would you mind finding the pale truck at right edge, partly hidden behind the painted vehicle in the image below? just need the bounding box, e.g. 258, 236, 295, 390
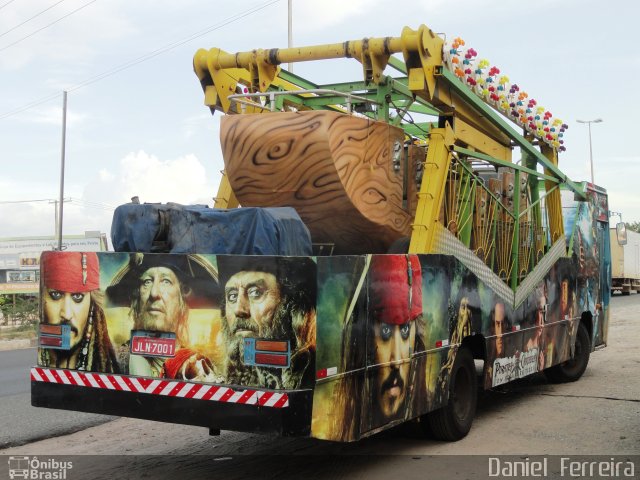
609, 228, 640, 295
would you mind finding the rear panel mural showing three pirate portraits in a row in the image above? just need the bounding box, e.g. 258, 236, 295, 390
39, 252, 316, 389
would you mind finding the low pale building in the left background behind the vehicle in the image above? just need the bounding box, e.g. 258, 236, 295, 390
0, 231, 108, 295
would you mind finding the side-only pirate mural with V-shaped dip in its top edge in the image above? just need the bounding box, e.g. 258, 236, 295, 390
312, 251, 596, 441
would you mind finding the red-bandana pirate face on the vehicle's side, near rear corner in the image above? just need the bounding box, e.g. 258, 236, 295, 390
369, 255, 423, 427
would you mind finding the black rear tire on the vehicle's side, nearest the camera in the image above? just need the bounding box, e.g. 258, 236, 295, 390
427, 347, 478, 441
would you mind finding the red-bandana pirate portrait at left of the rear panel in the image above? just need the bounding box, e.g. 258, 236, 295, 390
38, 252, 119, 373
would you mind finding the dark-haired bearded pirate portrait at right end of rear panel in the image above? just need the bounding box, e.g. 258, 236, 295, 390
217, 255, 317, 389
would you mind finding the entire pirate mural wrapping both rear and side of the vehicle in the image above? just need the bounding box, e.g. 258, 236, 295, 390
39, 224, 606, 441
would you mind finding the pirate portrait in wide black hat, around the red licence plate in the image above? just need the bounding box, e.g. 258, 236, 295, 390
107, 253, 222, 382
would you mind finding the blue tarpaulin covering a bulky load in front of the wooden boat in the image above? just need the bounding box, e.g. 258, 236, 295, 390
111, 203, 312, 256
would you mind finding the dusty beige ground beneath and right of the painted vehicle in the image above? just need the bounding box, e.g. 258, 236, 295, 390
0, 295, 640, 480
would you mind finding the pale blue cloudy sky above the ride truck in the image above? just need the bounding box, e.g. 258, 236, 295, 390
0, 0, 640, 248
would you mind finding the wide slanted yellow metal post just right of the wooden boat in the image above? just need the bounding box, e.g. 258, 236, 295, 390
409, 124, 455, 253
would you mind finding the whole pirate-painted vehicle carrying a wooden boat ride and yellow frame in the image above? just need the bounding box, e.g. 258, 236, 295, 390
31, 25, 611, 442
